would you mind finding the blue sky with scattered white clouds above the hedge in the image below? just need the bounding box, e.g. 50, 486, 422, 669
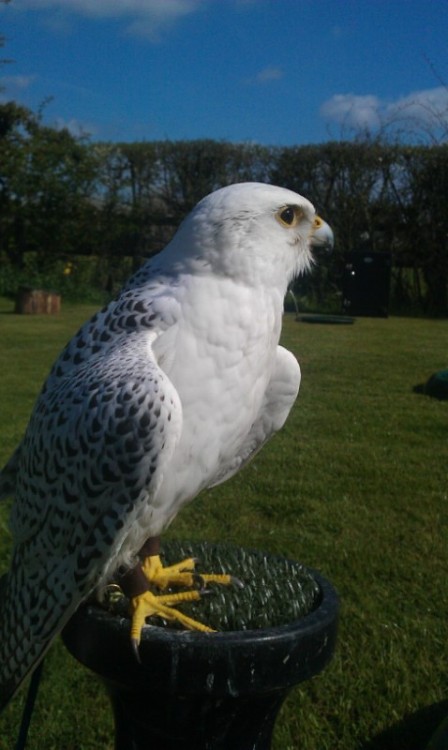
0, 0, 448, 145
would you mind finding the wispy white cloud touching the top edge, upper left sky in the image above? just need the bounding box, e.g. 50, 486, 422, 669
14, 0, 200, 39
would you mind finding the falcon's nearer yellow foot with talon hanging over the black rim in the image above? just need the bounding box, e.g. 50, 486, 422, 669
131, 591, 214, 657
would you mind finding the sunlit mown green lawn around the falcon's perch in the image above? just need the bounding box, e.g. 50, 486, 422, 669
0, 301, 448, 750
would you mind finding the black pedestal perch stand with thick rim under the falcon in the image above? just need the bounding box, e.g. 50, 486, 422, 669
63, 545, 338, 750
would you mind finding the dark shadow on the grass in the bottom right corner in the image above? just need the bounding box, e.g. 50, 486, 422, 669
360, 700, 448, 750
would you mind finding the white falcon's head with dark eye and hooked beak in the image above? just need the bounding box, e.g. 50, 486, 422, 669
170, 182, 333, 289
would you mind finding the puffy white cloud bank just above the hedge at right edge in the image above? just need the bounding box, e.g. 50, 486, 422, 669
320, 86, 448, 137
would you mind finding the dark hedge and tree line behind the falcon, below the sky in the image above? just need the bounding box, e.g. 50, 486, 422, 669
0, 102, 448, 316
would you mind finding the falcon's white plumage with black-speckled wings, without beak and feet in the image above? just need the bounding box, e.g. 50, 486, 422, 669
0, 183, 332, 706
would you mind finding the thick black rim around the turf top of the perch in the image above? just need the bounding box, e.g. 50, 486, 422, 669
63, 566, 339, 696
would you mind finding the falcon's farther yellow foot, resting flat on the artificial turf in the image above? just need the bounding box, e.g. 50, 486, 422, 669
142, 555, 233, 591
